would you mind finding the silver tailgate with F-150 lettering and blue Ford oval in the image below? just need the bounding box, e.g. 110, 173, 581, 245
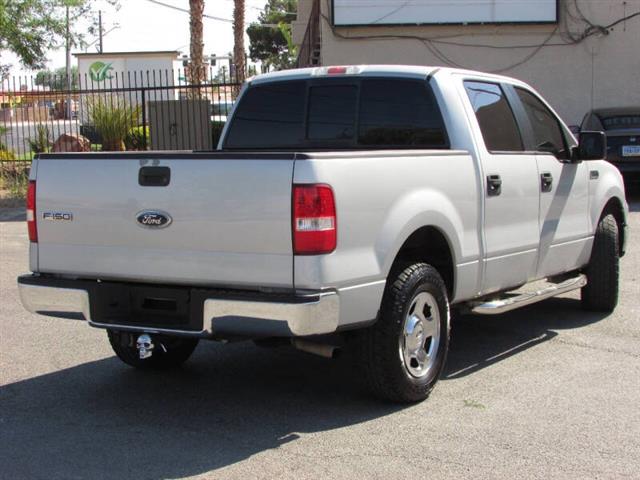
36, 152, 295, 288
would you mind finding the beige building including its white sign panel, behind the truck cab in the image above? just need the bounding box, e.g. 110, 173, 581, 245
293, 0, 640, 125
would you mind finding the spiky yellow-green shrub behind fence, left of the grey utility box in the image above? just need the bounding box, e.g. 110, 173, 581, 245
89, 99, 141, 151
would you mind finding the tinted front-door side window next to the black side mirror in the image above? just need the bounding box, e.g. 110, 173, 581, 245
516, 88, 567, 158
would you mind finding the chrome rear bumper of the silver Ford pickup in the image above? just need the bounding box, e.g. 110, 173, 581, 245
18, 275, 340, 338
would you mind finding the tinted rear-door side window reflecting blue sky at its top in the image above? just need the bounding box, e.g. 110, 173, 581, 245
464, 81, 524, 152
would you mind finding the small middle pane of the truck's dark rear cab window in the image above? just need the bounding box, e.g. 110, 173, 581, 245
308, 85, 357, 140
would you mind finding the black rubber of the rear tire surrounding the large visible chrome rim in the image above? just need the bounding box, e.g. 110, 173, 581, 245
354, 263, 450, 403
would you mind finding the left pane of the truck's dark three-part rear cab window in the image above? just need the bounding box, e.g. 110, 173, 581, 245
225, 81, 306, 149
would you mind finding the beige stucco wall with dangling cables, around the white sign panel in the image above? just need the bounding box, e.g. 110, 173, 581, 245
300, 0, 640, 124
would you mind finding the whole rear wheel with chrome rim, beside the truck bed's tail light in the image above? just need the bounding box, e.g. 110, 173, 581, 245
355, 263, 450, 402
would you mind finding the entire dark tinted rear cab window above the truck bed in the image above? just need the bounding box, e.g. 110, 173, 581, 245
223, 77, 449, 150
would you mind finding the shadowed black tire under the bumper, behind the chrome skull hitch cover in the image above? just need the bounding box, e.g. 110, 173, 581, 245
107, 330, 198, 370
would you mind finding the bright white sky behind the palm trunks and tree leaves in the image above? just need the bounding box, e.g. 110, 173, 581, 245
2, 0, 266, 75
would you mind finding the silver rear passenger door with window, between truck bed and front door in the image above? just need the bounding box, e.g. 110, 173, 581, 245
464, 80, 540, 292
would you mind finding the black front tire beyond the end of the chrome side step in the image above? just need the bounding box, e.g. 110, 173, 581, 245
581, 214, 620, 312
